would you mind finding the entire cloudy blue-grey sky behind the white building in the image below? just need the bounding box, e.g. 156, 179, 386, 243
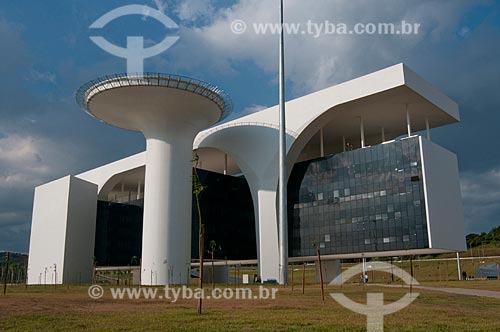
0, 0, 500, 252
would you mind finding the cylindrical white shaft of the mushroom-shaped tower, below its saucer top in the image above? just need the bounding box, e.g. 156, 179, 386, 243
141, 130, 194, 285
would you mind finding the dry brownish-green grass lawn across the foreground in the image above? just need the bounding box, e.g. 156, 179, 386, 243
0, 284, 500, 332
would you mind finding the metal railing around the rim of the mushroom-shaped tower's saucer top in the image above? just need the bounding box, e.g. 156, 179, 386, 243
76, 73, 233, 120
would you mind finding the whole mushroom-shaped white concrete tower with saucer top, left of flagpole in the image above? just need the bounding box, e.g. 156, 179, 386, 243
77, 74, 232, 285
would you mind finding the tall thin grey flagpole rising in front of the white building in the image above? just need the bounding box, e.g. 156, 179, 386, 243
278, 0, 288, 285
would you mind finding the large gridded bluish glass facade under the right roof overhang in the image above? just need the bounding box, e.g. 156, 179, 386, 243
288, 137, 429, 257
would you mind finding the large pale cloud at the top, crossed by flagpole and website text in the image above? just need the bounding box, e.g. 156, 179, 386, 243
169, 0, 482, 93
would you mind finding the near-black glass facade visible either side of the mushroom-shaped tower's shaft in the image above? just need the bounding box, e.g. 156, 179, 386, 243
94, 170, 257, 266
